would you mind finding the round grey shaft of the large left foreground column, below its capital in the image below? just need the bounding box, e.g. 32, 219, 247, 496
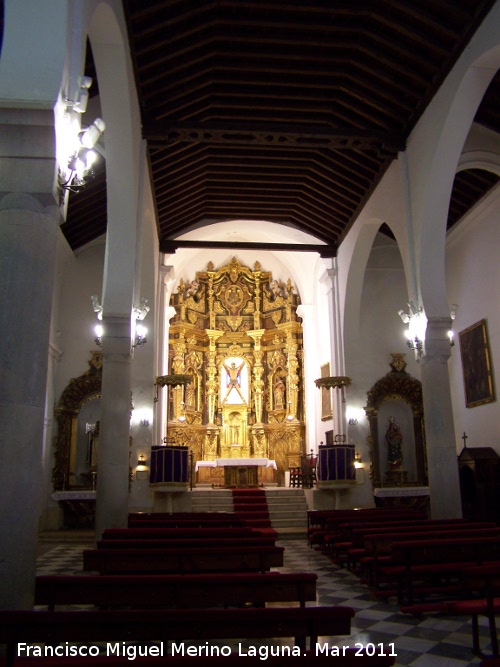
0, 194, 59, 609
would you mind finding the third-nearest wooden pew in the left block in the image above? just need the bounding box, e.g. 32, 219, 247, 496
83, 546, 284, 574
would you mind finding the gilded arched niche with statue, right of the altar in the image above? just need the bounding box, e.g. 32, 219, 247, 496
365, 354, 427, 488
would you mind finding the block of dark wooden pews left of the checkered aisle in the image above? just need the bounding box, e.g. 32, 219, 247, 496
0, 512, 395, 667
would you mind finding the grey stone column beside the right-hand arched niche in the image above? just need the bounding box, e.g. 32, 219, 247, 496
421, 317, 462, 519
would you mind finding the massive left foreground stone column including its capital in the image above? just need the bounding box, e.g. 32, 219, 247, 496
0, 103, 61, 609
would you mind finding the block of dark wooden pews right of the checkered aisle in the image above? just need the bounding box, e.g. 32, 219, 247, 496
308, 509, 500, 658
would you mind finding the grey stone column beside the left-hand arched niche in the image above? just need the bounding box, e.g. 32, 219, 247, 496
95, 315, 132, 539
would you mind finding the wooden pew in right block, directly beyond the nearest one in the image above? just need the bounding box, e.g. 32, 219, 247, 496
380, 537, 500, 605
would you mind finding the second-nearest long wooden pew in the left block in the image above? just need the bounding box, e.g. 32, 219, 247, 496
35, 572, 317, 611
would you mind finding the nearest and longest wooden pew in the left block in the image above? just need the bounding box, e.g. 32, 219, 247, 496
0, 606, 354, 667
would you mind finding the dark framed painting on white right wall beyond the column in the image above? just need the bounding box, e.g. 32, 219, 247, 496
458, 320, 495, 408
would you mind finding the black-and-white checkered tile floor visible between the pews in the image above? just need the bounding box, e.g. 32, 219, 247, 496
38, 538, 496, 667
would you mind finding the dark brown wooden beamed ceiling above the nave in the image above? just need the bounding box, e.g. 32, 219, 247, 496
65, 0, 500, 254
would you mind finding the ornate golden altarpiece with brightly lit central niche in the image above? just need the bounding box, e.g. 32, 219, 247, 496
164, 258, 304, 486
